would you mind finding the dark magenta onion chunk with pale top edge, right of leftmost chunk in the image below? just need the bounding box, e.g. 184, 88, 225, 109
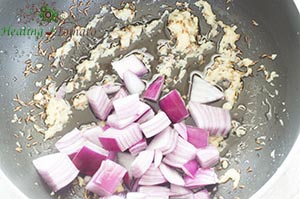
72, 141, 109, 176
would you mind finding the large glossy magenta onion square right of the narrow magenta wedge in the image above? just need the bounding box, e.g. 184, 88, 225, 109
159, 89, 189, 123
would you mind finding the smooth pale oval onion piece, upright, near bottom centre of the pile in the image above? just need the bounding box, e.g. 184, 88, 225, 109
130, 150, 154, 178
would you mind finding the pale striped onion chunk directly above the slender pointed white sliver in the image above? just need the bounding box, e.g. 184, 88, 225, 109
163, 137, 196, 168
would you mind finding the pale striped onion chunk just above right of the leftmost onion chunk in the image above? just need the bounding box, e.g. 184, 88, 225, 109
55, 128, 86, 159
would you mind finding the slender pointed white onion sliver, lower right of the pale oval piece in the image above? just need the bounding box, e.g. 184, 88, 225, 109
159, 163, 184, 186
